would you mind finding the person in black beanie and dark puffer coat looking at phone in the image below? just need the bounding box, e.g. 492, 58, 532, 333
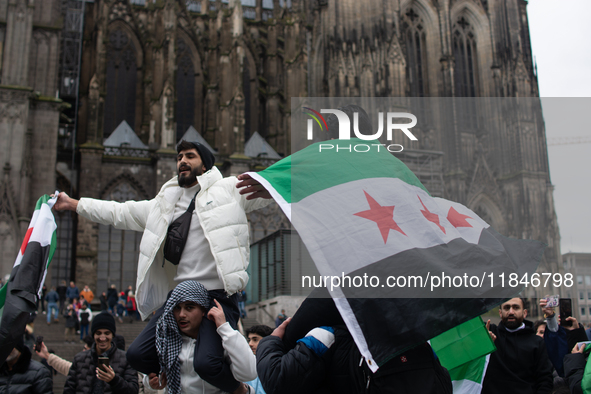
64, 312, 139, 394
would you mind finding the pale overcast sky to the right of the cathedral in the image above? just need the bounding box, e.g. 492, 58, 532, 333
527, 0, 591, 254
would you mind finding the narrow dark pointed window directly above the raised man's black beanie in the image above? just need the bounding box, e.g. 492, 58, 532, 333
175, 38, 198, 142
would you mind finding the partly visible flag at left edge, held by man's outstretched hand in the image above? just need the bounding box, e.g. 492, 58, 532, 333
0, 192, 58, 365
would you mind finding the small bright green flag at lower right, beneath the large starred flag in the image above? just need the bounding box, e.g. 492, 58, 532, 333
429, 317, 496, 394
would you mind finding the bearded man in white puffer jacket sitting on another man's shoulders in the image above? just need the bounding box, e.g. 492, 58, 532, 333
54, 141, 271, 393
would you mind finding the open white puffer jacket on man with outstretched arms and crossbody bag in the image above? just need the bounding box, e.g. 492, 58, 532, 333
76, 167, 271, 319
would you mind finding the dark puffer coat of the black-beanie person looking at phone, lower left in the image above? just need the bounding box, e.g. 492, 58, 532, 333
64, 343, 139, 394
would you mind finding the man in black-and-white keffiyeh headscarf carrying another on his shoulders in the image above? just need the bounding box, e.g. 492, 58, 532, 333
147, 281, 256, 394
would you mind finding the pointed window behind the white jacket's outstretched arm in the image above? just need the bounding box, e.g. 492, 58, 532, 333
96, 182, 142, 294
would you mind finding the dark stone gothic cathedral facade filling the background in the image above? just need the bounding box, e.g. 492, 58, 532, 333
0, 0, 562, 304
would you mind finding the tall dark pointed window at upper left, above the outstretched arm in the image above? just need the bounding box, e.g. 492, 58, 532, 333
103, 29, 137, 138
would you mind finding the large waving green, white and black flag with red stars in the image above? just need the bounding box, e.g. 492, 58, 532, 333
249, 139, 544, 371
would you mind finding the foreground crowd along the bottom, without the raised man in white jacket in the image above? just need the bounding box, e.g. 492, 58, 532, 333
9, 290, 591, 394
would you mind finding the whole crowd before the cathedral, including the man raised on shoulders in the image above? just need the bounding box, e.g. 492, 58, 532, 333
0, 136, 591, 394
